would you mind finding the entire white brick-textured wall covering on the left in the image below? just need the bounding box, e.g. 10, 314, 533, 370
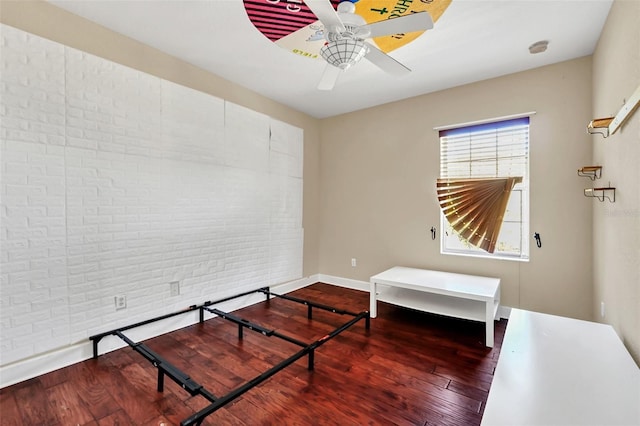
0, 25, 303, 366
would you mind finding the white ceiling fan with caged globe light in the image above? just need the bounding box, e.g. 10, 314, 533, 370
304, 0, 433, 90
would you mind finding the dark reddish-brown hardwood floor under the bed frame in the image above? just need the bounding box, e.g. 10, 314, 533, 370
0, 284, 506, 426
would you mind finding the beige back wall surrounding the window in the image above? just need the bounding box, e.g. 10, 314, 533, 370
319, 57, 592, 319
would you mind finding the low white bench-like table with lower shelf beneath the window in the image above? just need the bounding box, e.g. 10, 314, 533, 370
369, 266, 500, 347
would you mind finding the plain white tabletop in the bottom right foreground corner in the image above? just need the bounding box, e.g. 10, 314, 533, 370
482, 309, 640, 426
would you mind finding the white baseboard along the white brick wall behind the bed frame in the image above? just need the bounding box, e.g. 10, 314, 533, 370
0, 275, 319, 389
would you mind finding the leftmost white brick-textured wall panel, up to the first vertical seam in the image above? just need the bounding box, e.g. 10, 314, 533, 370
0, 27, 69, 364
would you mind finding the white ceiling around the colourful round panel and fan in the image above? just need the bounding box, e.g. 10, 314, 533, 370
49, 0, 612, 118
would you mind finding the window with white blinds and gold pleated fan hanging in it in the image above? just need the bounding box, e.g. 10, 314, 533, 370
438, 116, 529, 260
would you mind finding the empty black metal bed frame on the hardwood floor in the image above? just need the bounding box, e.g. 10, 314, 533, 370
89, 287, 370, 426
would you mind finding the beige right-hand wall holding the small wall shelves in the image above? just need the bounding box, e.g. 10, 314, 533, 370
592, 0, 640, 364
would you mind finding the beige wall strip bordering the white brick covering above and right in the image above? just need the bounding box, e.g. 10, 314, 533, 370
0, 0, 320, 275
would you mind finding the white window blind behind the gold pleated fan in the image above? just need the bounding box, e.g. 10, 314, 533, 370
440, 117, 529, 259
